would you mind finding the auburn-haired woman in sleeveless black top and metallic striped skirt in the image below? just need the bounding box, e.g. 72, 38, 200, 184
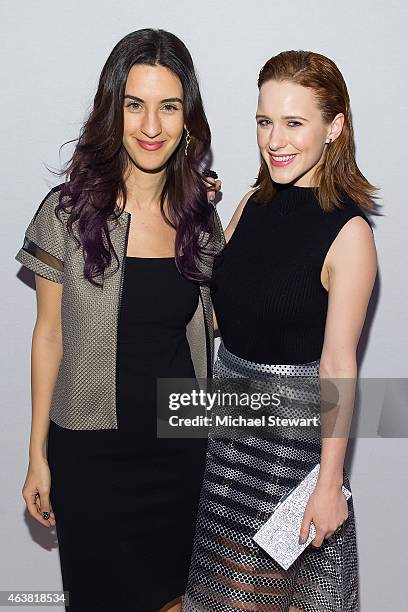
182, 51, 377, 612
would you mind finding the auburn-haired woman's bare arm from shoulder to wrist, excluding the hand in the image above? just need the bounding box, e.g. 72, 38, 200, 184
318, 217, 377, 487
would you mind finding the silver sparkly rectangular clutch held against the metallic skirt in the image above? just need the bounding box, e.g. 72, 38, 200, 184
253, 463, 351, 569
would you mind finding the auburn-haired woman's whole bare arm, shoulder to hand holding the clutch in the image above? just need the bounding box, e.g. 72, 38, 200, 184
301, 217, 377, 546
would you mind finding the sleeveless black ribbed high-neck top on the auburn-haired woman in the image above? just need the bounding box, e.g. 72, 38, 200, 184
211, 185, 371, 364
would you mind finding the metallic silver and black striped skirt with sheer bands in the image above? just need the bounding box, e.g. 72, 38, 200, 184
182, 344, 360, 612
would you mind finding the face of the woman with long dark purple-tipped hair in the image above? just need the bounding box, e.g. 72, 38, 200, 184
123, 64, 184, 172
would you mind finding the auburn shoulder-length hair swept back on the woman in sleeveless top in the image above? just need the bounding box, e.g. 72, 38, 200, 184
253, 51, 378, 212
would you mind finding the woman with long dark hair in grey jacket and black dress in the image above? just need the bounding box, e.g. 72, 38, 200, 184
16, 29, 224, 612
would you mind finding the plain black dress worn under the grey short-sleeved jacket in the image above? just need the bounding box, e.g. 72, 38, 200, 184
47, 257, 207, 612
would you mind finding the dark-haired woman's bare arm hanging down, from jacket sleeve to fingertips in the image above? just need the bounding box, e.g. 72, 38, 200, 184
23, 274, 62, 527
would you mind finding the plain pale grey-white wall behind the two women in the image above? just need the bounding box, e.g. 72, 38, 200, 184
0, 0, 408, 612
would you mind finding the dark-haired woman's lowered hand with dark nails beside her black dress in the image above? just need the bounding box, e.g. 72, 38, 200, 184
22, 458, 55, 527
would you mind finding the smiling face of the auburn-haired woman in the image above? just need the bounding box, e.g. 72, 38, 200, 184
256, 80, 344, 187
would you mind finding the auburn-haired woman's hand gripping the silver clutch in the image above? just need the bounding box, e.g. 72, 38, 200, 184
300, 485, 348, 548
